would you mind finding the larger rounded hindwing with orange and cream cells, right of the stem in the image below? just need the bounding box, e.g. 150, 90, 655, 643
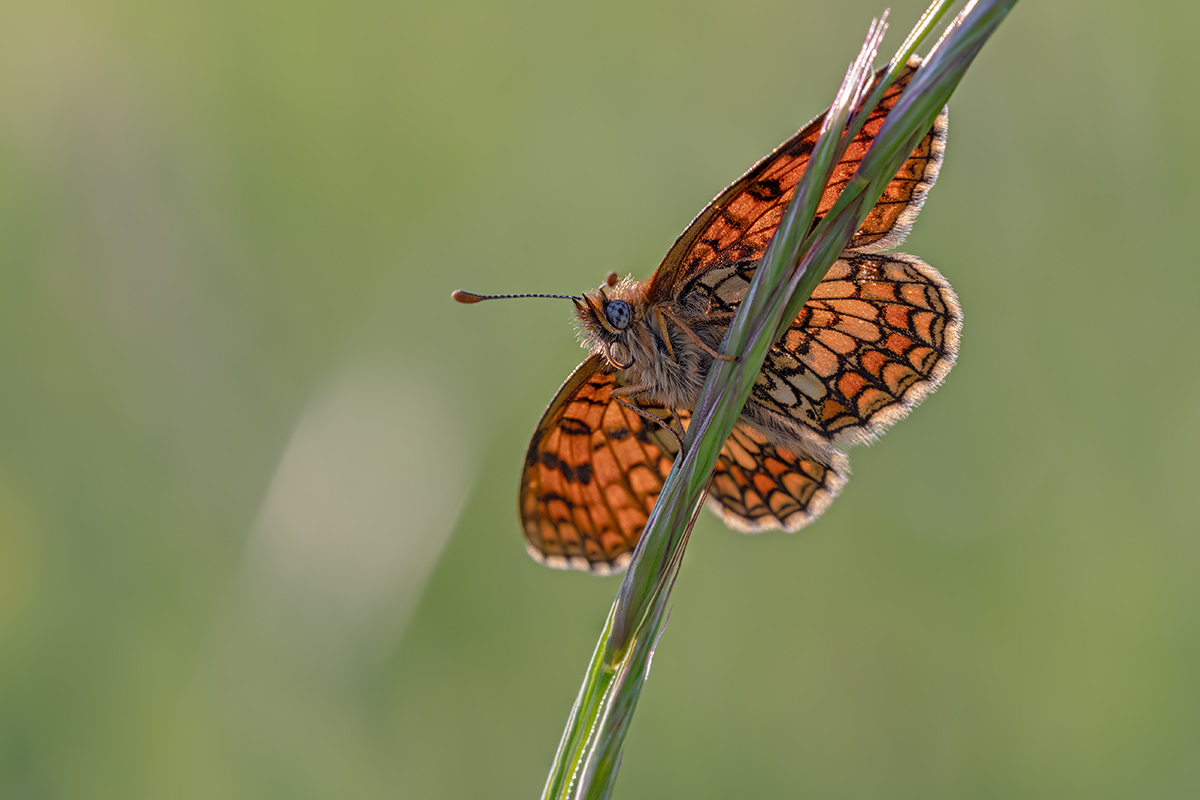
743, 253, 962, 452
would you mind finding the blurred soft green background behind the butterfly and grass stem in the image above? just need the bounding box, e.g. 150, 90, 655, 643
0, 0, 1200, 800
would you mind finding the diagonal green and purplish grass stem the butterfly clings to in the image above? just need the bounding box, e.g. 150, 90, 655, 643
542, 0, 1016, 799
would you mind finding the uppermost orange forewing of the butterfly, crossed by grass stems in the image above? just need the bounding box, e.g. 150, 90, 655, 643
649, 58, 947, 300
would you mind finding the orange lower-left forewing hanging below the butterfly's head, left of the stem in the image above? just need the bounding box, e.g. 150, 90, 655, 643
520, 355, 678, 575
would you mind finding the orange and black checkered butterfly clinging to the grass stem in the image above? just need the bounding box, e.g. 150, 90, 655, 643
455, 59, 962, 575
